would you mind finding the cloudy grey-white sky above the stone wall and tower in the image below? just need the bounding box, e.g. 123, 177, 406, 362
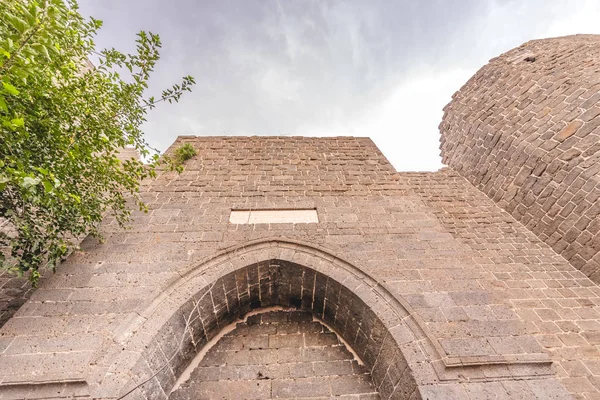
80, 0, 600, 171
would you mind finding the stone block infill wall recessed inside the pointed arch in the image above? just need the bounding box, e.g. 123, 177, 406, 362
169, 311, 380, 400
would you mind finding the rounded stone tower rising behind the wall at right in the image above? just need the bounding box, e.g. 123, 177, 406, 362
440, 35, 600, 282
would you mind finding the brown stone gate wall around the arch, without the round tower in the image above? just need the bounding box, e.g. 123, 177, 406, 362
0, 137, 580, 399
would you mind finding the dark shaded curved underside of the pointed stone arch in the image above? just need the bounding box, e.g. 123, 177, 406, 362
135, 260, 417, 399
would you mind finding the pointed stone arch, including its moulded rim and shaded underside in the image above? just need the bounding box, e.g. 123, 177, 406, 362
98, 239, 424, 399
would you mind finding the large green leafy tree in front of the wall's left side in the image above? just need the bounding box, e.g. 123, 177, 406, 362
0, 0, 194, 284
